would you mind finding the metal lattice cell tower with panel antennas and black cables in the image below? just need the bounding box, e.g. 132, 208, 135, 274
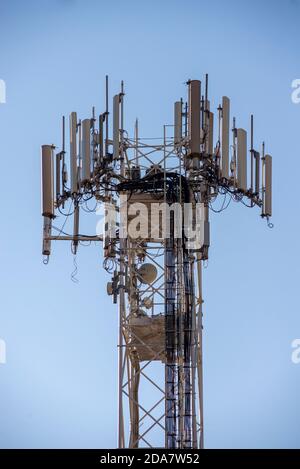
42, 75, 272, 449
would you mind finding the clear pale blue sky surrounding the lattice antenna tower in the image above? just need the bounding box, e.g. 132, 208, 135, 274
0, 0, 300, 448
